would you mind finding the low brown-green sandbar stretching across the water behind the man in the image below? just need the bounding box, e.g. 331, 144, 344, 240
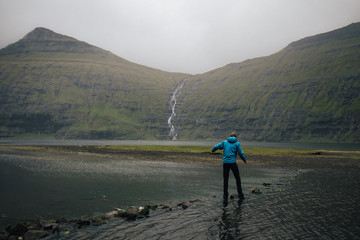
5, 145, 360, 168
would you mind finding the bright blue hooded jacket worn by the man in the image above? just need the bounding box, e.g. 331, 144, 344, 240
211, 137, 246, 163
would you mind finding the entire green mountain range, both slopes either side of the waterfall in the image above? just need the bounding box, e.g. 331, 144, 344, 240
0, 23, 360, 142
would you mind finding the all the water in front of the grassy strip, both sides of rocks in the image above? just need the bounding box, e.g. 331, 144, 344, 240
0, 149, 360, 239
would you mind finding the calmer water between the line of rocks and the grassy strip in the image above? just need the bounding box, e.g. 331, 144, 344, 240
0, 149, 295, 228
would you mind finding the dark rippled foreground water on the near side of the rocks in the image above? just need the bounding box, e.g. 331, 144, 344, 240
49, 168, 360, 239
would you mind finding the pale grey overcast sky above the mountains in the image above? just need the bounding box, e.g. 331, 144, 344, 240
0, 0, 360, 74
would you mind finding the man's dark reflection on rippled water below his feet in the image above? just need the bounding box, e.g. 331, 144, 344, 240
219, 200, 242, 240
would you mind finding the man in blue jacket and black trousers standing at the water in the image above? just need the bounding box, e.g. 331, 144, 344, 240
211, 132, 246, 201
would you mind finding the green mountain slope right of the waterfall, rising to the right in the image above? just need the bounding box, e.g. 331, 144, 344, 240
173, 23, 360, 143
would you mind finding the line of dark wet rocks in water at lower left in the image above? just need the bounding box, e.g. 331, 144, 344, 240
0, 199, 201, 240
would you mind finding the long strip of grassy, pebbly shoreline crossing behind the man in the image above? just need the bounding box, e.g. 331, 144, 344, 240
0, 145, 360, 168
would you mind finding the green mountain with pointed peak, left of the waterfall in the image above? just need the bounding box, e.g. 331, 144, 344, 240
0, 28, 188, 139
